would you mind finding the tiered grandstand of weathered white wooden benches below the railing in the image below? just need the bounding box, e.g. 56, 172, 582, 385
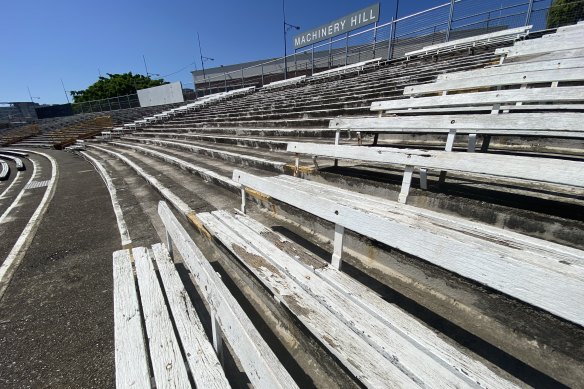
81, 25, 584, 387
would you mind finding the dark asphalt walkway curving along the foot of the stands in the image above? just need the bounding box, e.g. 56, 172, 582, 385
0, 150, 121, 388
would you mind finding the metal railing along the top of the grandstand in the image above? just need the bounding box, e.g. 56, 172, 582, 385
193, 0, 584, 96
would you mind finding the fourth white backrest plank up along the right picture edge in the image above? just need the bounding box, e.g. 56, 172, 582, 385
371, 86, 584, 111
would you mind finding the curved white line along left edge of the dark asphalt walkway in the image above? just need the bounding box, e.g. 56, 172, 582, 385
0, 150, 59, 300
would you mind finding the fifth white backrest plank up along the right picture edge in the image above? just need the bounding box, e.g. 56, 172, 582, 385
404, 68, 584, 95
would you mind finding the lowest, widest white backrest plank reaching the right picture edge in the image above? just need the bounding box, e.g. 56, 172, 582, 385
233, 170, 584, 325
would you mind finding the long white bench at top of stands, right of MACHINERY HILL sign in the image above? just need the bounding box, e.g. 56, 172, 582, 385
405, 26, 533, 59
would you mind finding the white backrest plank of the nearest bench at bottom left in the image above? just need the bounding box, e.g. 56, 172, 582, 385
158, 202, 297, 389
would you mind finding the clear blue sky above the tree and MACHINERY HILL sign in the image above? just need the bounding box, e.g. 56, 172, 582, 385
0, 0, 446, 104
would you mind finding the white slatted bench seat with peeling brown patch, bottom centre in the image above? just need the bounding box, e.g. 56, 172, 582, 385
197, 211, 513, 388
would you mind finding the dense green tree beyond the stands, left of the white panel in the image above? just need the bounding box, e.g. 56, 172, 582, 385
71, 72, 167, 103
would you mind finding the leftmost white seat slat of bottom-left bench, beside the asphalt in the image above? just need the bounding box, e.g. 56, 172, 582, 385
113, 250, 151, 389
